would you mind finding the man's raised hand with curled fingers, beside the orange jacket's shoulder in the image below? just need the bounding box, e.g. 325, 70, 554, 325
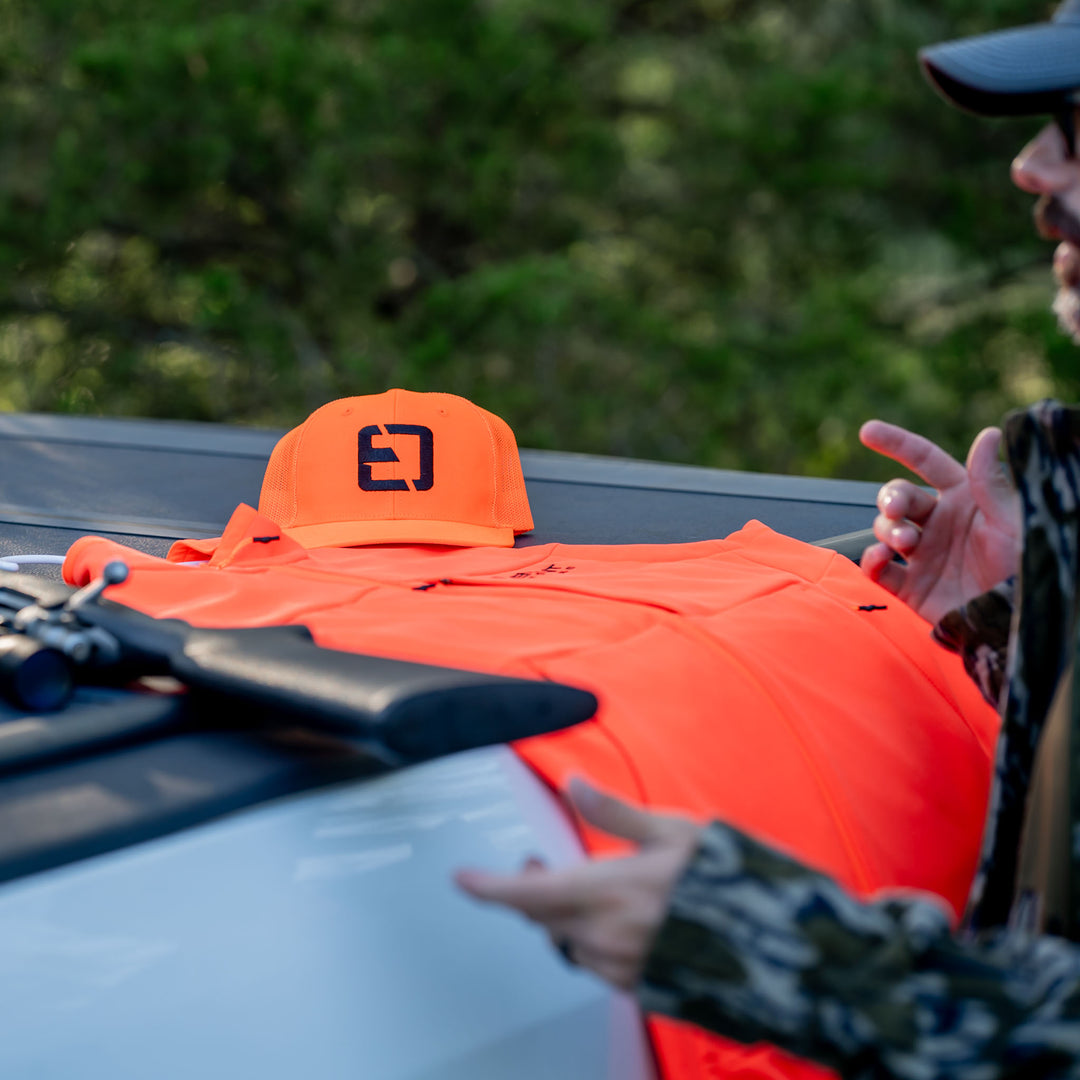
859, 420, 1021, 622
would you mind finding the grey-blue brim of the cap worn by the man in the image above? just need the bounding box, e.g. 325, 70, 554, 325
919, 22, 1080, 117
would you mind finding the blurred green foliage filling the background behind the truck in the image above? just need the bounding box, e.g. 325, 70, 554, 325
0, 0, 1080, 476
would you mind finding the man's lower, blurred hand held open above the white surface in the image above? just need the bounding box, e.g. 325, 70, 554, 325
455, 779, 700, 990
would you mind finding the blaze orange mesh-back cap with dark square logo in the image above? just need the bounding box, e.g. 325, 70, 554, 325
259, 390, 532, 548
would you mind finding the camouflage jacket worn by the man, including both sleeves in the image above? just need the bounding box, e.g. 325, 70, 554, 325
638, 402, 1080, 1080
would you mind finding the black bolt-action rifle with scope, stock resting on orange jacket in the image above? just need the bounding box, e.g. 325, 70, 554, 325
0, 562, 597, 768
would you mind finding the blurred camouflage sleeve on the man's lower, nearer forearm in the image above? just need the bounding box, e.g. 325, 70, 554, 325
638, 824, 1080, 1080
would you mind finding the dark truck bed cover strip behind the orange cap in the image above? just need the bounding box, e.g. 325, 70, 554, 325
0, 414, 877, 556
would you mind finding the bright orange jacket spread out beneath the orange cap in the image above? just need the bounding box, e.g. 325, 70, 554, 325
65, 507, 997, 1078
